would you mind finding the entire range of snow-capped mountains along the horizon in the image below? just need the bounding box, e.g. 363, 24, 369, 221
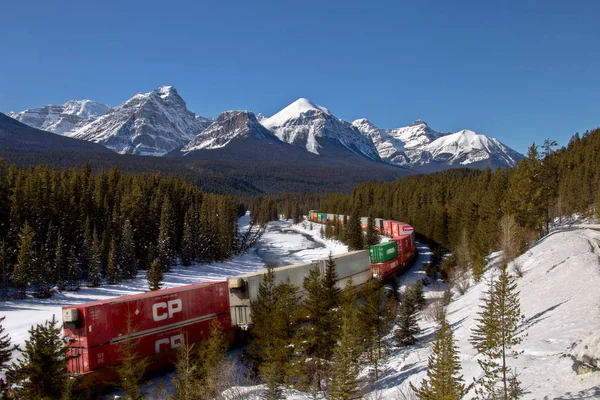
9, 86, 523, 172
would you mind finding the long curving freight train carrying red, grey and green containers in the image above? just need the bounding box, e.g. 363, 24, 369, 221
62, 213, 416, 386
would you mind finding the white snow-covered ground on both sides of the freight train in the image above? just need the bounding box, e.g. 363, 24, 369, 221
0, 221, 600, 400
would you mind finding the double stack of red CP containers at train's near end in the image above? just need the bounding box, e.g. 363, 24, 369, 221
62, 281, 231, 374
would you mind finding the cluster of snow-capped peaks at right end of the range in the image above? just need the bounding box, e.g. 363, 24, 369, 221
352, 119, 523, 171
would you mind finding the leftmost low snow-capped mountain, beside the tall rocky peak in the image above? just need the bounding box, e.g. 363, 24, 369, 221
8, 100, 110, 135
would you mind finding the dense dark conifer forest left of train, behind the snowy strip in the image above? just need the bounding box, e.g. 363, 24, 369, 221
0, 160, 241, 297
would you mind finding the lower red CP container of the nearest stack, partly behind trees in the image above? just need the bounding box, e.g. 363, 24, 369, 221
68, 312, 231, 374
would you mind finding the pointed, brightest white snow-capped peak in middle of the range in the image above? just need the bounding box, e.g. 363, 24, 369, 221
260, 98, 380, 161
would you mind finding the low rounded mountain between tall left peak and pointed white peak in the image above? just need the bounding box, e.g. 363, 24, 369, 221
181, 111, 278, 153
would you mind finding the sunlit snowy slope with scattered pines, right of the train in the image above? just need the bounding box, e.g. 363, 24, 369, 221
374, 229, 600, 399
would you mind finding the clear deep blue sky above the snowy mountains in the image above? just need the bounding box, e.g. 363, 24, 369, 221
0, 0, 600, 152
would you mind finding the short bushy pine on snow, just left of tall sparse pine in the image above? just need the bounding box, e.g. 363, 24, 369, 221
410, 314, 468, 400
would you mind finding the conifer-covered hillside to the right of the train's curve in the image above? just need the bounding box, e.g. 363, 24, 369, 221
260, 129, 600, 259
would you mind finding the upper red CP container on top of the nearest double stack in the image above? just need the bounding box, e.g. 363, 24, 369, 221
63, 282, 229, 348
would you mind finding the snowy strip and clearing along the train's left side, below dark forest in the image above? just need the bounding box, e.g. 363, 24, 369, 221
0, 217, 347, 354
